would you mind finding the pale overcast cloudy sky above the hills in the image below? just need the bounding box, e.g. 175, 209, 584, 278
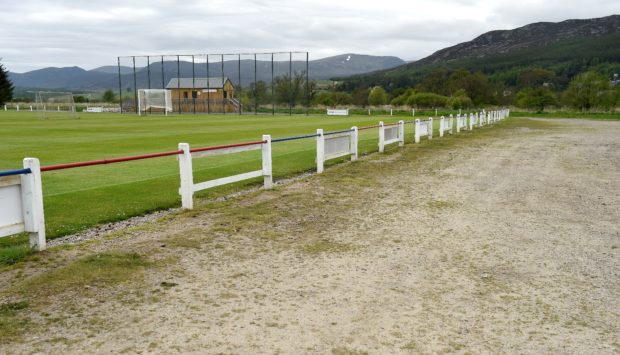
0, 0, 620, 73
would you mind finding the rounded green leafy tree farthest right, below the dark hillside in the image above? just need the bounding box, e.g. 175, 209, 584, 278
564, 71, 614, 111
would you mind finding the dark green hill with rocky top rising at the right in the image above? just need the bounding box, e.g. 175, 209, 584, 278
343, 15, 620, 89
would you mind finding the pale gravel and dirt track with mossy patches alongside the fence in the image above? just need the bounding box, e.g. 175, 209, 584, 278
1, 120, 620, 354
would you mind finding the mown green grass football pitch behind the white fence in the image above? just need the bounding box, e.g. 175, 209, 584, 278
0, 112, 452, 245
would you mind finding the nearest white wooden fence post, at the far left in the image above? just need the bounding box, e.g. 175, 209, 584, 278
21, 158, 46, 250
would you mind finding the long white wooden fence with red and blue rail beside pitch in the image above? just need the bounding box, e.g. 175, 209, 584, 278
0, 109, 510, 250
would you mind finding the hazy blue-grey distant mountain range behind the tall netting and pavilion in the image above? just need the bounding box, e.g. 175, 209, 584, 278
9, 54, 405, 91
